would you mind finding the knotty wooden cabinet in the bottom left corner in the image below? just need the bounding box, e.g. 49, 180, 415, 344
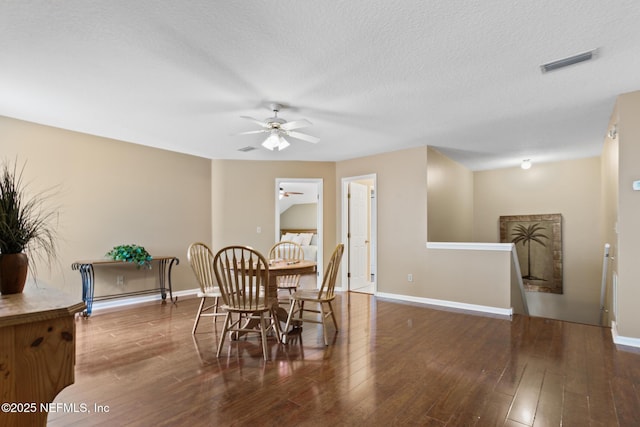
0, 289, 85, 426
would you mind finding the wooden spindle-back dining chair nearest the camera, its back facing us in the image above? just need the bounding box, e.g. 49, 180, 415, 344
213, 246, 280, 360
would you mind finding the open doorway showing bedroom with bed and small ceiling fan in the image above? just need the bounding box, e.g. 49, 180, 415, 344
274, 178, 324, 288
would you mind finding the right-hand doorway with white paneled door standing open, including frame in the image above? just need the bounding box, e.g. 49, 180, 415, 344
342, 174, 377, 294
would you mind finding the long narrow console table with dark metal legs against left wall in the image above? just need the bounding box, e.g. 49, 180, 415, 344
71, 256, 180, 317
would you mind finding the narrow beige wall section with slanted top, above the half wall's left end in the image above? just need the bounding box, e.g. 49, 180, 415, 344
427, 147, 473, 242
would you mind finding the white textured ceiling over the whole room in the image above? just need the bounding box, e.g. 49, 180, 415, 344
0, 0, 640, 170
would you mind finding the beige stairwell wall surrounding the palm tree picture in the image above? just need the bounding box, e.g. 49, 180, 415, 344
473, 157, 603, 323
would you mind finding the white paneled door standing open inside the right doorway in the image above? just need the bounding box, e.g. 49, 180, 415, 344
349, 182, 369, 290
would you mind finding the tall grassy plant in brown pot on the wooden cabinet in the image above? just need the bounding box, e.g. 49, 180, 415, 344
0, 161, 58, 294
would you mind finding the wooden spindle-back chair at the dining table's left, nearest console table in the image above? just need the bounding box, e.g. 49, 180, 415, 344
187, 242, 225, 334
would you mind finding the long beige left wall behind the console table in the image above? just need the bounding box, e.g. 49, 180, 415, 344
0, 117, 211, 297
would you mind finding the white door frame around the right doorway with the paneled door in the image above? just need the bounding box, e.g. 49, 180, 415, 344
341, 173, 379, 295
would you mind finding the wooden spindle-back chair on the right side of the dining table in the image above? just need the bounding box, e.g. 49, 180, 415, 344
283, 243, 344, 345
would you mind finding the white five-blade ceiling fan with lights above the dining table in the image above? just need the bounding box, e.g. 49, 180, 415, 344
239, 104, 320, 151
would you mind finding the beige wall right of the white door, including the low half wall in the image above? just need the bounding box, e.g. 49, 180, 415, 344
336, 147, 510, 308
